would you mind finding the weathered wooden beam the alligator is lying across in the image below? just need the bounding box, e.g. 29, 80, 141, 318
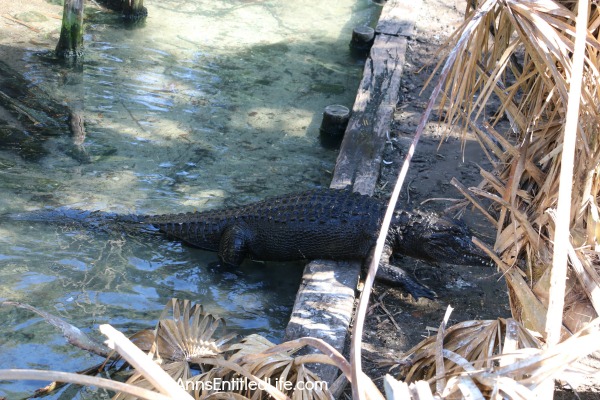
285, 0, 421, 386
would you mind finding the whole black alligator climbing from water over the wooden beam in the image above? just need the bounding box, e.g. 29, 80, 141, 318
5, 189, 491, 299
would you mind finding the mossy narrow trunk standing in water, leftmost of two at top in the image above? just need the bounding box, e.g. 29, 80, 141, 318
56, 0, 83, 58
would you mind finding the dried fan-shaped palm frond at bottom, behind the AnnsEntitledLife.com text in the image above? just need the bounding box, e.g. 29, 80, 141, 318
109, 299, 364, 400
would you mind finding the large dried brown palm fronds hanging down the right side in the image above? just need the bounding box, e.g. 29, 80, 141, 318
428, 0, 600, 340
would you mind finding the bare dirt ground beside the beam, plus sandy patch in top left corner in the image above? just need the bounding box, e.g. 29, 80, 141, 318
0, 0, 596, 398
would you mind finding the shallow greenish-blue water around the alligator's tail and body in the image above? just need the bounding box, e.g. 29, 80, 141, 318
0, 0, 379, 398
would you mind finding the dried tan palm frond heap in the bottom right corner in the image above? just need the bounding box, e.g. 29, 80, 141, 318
386, 319, 600, 399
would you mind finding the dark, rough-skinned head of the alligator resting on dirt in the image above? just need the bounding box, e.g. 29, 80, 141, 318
392, 211, 492, 265
